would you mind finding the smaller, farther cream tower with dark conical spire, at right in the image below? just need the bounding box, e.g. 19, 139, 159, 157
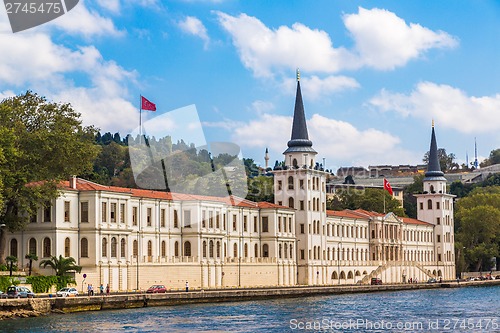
415, 121, 455, 279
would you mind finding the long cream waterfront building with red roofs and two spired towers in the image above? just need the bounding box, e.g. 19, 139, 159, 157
3, 74, 455, 290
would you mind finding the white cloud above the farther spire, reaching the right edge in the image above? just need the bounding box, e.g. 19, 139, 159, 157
369, 82, 500, 133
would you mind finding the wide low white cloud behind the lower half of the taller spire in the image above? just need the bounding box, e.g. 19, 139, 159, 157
232, 113, 414, 167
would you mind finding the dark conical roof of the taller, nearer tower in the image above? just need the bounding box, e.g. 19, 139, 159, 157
284, 79, 316, 153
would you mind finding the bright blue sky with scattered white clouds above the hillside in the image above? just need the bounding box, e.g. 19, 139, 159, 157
0, 0, 500, 170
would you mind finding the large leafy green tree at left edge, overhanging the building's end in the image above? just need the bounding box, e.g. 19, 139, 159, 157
0, 91, 97, 263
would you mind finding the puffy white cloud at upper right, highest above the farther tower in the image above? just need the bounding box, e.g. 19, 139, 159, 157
343, 7, 458, 70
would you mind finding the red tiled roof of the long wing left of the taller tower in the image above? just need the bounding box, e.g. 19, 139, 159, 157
60, 178, 290, 209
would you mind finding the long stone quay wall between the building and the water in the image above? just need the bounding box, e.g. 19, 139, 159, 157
0, 280, 500, 320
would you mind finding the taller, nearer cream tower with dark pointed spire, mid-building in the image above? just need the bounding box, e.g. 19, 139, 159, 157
273, 70, 330, 285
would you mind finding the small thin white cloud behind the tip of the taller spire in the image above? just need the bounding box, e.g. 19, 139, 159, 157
283, 75, 360, 99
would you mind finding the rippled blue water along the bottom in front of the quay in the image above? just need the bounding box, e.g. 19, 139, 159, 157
0, 286, 500, 332
